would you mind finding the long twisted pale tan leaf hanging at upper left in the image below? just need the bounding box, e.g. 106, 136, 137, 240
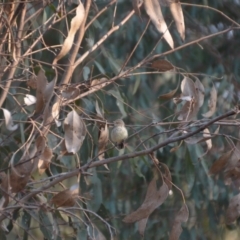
53, 2, 85, 65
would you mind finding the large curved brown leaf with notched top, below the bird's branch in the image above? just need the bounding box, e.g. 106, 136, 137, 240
123, 179, 169, 223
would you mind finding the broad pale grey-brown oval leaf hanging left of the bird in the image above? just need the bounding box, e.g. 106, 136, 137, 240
64, 110, 86, 154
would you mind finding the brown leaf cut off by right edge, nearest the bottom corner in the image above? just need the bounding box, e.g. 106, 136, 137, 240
226, 193, 240, 224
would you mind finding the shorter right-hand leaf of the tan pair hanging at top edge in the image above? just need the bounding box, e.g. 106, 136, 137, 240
169, 1, 185, 41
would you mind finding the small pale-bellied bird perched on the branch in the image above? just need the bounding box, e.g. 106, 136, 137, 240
111, 119, 128, 149
